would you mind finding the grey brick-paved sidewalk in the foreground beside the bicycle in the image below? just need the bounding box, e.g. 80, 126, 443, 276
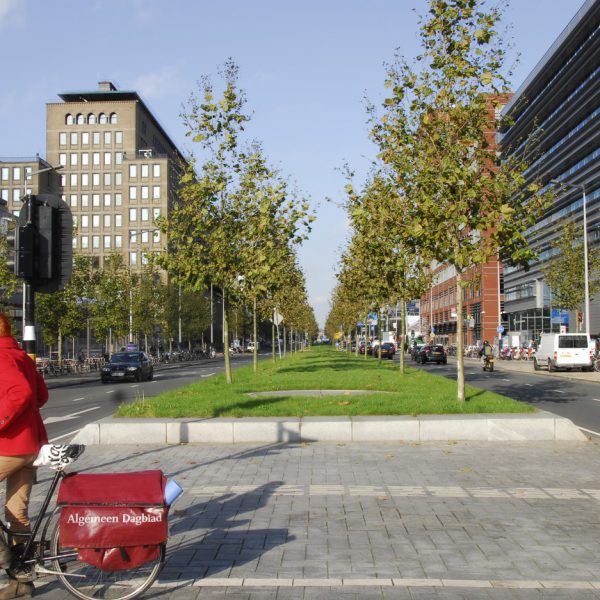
15, 442, 600, 600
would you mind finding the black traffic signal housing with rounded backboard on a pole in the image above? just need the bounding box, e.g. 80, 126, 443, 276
17, 194, 73, 293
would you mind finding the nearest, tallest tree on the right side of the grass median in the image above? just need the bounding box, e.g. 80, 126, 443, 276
372, 0, 546, 401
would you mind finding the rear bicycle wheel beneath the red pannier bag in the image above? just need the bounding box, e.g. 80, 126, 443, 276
50, 523, 165, 600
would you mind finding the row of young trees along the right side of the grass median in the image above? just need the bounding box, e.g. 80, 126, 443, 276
328, 0, 550, 401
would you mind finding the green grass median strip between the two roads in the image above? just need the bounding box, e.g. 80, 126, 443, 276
116, 346, 536, 418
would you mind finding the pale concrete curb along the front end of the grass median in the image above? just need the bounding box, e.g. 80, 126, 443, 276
73, 412, 588, 445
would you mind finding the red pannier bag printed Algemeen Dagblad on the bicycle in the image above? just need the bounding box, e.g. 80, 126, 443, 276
57, 470, 168, 571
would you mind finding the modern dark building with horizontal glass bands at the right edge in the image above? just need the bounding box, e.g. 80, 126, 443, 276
499, 0, 600, 342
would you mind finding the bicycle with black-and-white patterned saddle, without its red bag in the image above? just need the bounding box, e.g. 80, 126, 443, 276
0, 444, 166, 600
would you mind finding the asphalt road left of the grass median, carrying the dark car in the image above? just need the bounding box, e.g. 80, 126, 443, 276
42, 354, 252, 443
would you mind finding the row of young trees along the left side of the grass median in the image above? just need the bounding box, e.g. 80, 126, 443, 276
157, 60, 317, 383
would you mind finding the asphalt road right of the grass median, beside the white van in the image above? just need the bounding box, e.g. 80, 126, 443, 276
406, 358, 600, 436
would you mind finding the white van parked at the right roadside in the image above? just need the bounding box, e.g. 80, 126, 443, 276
533, 333, 594, 371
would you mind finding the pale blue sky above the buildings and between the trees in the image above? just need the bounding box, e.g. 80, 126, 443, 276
0, 0, 583, 324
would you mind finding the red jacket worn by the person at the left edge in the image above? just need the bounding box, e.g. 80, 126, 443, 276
0, 337, 48, 456
